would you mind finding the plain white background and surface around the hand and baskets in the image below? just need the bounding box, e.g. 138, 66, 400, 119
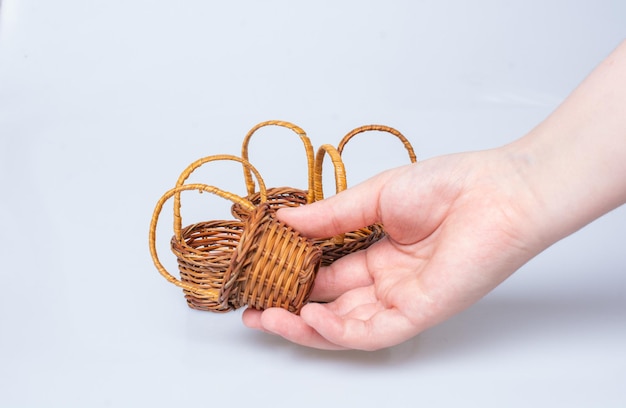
0, 0, 626, 407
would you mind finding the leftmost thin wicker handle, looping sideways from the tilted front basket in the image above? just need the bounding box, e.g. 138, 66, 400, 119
148, 184, 256, 301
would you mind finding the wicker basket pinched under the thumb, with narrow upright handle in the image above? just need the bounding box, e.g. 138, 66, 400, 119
315, 144, 385, 266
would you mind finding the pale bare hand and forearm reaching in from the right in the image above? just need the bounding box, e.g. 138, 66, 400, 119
243, 41, 626, 350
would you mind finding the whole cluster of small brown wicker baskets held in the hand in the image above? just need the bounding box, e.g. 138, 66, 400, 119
149, 121, 416, 314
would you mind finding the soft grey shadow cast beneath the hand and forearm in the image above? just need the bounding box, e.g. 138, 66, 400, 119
236, 276, 624, 368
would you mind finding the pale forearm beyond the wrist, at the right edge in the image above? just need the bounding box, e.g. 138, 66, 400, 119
505, 41, 626, 245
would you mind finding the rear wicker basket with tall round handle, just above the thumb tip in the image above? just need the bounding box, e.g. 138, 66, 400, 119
231, 120, 315, 219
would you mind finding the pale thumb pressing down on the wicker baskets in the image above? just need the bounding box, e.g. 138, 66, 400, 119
276, 172, 389, 238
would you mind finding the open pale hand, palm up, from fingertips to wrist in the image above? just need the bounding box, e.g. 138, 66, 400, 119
243, 149, 544, 350
